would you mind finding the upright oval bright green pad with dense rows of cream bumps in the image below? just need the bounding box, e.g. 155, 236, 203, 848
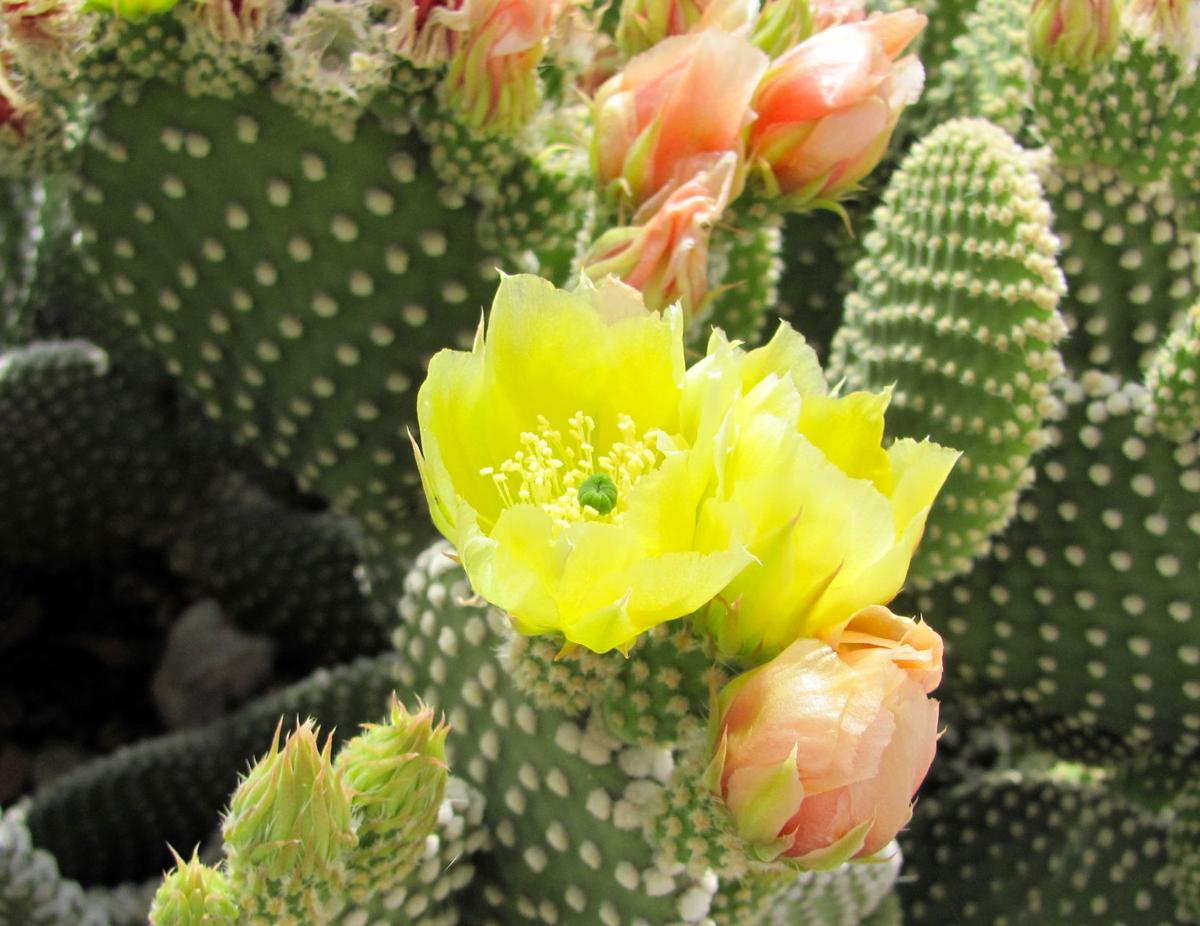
832, 120, 1066, 584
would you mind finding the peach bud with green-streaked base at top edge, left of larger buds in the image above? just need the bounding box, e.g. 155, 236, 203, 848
446, 0, 559, 132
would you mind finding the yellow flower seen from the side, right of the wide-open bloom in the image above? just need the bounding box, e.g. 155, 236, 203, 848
689, 325, 959, 663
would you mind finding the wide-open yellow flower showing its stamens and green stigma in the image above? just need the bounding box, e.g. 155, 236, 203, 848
418, 276, 750, 653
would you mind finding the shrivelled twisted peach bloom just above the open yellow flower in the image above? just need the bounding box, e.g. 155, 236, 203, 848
583, 152, 737, 315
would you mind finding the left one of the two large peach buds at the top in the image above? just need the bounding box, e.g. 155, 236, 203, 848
592, 29, 768, 205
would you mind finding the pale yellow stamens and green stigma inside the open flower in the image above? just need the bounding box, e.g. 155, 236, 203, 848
480, 411, 662, 529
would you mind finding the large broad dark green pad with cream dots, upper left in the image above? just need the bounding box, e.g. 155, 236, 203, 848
76, 84, 491, 546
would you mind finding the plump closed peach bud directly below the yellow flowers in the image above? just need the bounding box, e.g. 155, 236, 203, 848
709, 607, 942, 867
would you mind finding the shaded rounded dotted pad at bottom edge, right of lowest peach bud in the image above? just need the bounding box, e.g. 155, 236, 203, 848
900, 769, 1175, 926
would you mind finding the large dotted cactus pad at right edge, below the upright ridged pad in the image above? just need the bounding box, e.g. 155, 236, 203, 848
916, 372, 1200, 763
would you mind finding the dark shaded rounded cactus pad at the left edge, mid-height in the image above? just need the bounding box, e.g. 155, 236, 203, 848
0, 341, 214, 559
